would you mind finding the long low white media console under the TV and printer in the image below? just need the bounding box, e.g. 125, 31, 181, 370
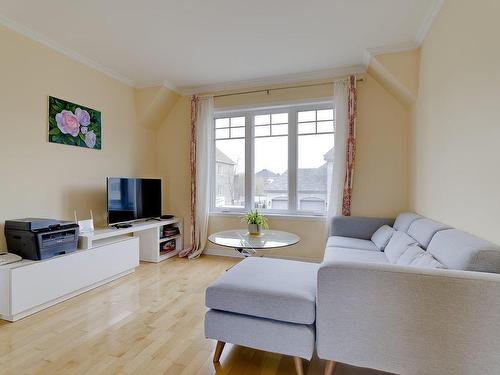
0, 218, 182, 322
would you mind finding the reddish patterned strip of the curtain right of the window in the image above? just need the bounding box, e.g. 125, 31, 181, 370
342, 76, 357, 216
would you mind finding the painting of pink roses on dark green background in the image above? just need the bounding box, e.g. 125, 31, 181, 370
49, 96, 102, 150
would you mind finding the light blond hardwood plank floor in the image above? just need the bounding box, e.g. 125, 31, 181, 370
0, 256, 390, 375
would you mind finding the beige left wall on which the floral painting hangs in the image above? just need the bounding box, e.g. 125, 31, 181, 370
0, 27, 156, 249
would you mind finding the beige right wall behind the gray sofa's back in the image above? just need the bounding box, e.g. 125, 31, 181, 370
410, 0, 500, 243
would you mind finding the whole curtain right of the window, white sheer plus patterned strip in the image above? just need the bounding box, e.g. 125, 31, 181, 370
327, 76, 356, 225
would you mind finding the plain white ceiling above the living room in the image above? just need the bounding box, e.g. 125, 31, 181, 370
0, 0, 439, 91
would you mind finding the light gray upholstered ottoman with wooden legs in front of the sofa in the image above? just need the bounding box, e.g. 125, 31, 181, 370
205, 258, 319, 374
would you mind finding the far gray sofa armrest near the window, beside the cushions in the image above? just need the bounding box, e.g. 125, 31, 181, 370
330, 216, 394, 240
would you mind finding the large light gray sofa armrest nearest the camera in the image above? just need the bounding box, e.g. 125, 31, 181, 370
316, 262, 500, 375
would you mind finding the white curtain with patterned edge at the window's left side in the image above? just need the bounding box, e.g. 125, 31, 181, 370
179, 96, 214, 259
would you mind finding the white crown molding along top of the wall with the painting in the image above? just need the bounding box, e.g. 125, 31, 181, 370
0, 14, 135, 87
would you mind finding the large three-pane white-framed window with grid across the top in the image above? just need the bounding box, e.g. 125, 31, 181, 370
212, 103, 335, 215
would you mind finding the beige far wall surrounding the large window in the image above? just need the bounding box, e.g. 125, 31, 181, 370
158, 75, 409, 260
